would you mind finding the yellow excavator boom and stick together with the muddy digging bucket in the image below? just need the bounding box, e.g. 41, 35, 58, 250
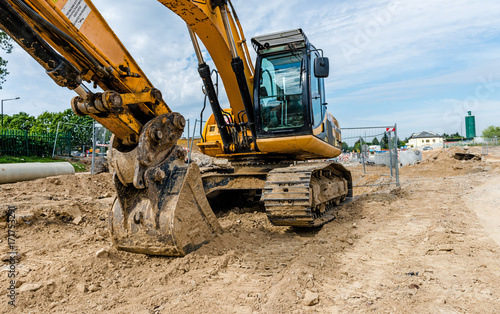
0, 0, 253, 256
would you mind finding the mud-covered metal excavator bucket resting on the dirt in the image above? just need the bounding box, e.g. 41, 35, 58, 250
109, 161, 222, 256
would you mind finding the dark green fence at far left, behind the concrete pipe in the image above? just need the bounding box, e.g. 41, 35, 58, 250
0, 129, 72, 157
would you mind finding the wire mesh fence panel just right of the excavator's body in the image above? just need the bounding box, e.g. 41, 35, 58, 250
337, 125, 399, 187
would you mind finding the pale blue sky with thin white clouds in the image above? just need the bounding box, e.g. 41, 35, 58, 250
0, 0, 500, 138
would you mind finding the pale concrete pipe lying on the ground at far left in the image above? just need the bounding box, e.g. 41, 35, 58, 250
0, 162, 75, 184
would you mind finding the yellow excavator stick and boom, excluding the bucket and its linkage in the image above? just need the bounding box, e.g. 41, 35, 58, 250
0, 0, 253, 146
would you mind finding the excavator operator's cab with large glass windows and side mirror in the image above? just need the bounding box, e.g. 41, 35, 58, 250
252, 29, 340, 159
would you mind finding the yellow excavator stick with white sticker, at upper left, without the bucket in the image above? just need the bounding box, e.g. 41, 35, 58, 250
1, 0, 171, 145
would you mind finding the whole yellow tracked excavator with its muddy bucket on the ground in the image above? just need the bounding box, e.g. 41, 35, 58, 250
0, 0, 352, 256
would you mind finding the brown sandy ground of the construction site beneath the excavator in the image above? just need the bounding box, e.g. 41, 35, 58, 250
0, 146, 500, 313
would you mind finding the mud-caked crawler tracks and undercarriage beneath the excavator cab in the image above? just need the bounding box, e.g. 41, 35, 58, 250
202, 161, 352, 227
